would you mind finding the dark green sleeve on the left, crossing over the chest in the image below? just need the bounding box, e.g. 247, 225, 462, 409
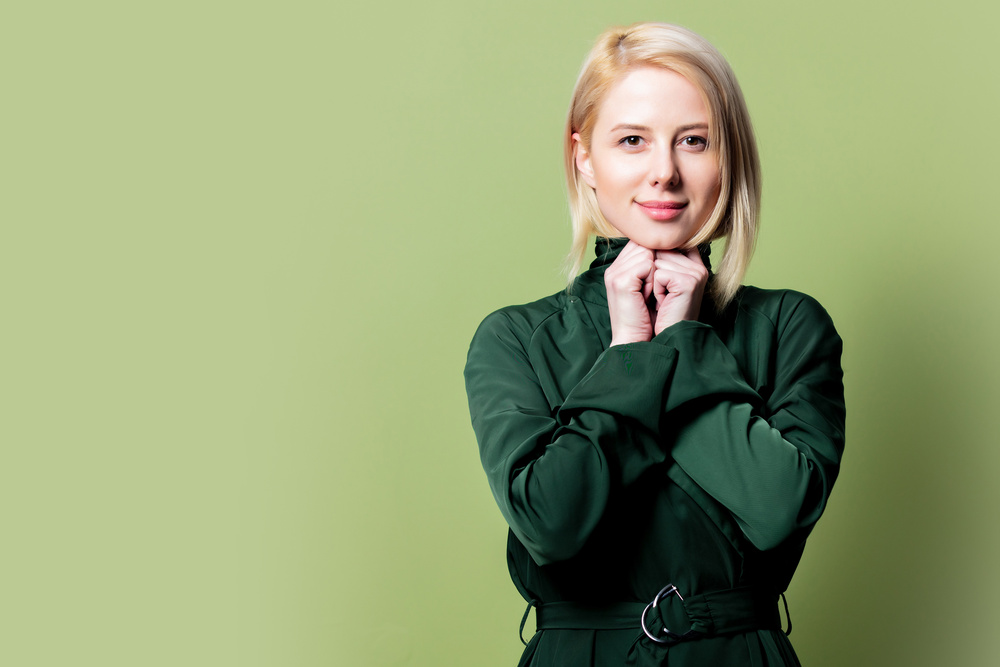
465, 311, 756, 565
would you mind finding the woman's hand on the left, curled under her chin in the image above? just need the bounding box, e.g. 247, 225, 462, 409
604, 241, 656, 345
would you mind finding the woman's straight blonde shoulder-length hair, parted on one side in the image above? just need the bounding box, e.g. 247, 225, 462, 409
563, 23, 761, 310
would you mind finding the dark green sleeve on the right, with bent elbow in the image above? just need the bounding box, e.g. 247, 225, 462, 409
653, 295, 845, 550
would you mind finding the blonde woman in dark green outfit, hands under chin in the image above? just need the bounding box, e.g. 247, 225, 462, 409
465, 24, 844, 667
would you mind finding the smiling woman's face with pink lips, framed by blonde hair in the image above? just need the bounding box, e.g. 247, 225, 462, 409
573, 67, 719, 250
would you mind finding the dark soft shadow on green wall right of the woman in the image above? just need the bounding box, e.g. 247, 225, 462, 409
808, 252, 1000, 665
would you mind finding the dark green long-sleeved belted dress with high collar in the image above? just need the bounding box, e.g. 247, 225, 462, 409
465, 239, 844, 667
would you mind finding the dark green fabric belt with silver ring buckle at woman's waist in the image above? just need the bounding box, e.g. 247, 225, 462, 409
521, 584, 792, 644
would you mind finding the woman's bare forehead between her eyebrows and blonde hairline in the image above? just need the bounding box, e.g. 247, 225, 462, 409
595, 66, 709, 129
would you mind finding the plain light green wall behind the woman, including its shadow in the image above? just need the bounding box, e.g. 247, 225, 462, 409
0, 0, 1000, 667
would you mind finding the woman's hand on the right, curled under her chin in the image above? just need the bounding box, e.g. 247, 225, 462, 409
653, 248, 708, 335
